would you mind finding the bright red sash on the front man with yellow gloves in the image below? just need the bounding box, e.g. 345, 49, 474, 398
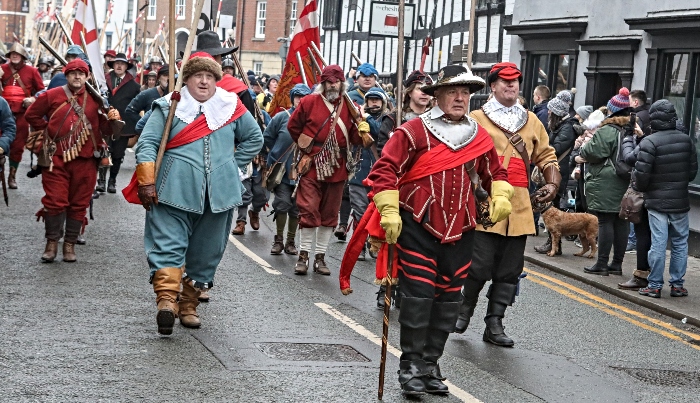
339, 128, 493, 291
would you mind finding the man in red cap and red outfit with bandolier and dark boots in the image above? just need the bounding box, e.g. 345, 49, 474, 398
25, 58, 120, 263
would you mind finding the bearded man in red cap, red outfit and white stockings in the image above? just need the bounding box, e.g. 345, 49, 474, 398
287, 64, 369, 276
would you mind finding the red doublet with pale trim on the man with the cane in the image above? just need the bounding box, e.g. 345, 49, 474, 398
367, 119, 508, 243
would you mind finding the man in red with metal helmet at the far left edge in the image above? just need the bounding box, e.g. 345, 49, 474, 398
0, 42, 44, 189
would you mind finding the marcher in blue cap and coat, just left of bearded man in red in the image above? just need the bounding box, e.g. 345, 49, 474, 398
263, 84, 311, 255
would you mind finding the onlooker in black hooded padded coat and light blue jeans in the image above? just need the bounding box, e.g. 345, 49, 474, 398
632, 99, 698, 298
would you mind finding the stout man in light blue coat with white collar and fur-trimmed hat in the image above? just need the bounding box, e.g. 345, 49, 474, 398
132, 52, 263, 335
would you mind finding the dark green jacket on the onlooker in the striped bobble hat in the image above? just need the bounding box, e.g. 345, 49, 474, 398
579, 116, 629, 213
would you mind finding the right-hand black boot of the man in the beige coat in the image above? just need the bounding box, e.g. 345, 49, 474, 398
484, 283, 518, 347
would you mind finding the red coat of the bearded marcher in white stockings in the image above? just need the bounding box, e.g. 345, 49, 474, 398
287, 94, 362, 182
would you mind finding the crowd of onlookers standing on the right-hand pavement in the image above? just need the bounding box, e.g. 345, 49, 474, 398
532, 86, 698, 298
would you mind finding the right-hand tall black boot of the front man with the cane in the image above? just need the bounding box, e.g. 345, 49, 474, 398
423, 302, 462, 394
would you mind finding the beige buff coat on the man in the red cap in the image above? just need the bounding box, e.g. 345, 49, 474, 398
469, 109, 558, 236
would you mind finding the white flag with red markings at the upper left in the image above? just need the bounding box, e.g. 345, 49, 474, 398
71, 0, 107, 89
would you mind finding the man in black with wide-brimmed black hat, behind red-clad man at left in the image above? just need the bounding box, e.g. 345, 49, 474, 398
100, 53, 141, 193
